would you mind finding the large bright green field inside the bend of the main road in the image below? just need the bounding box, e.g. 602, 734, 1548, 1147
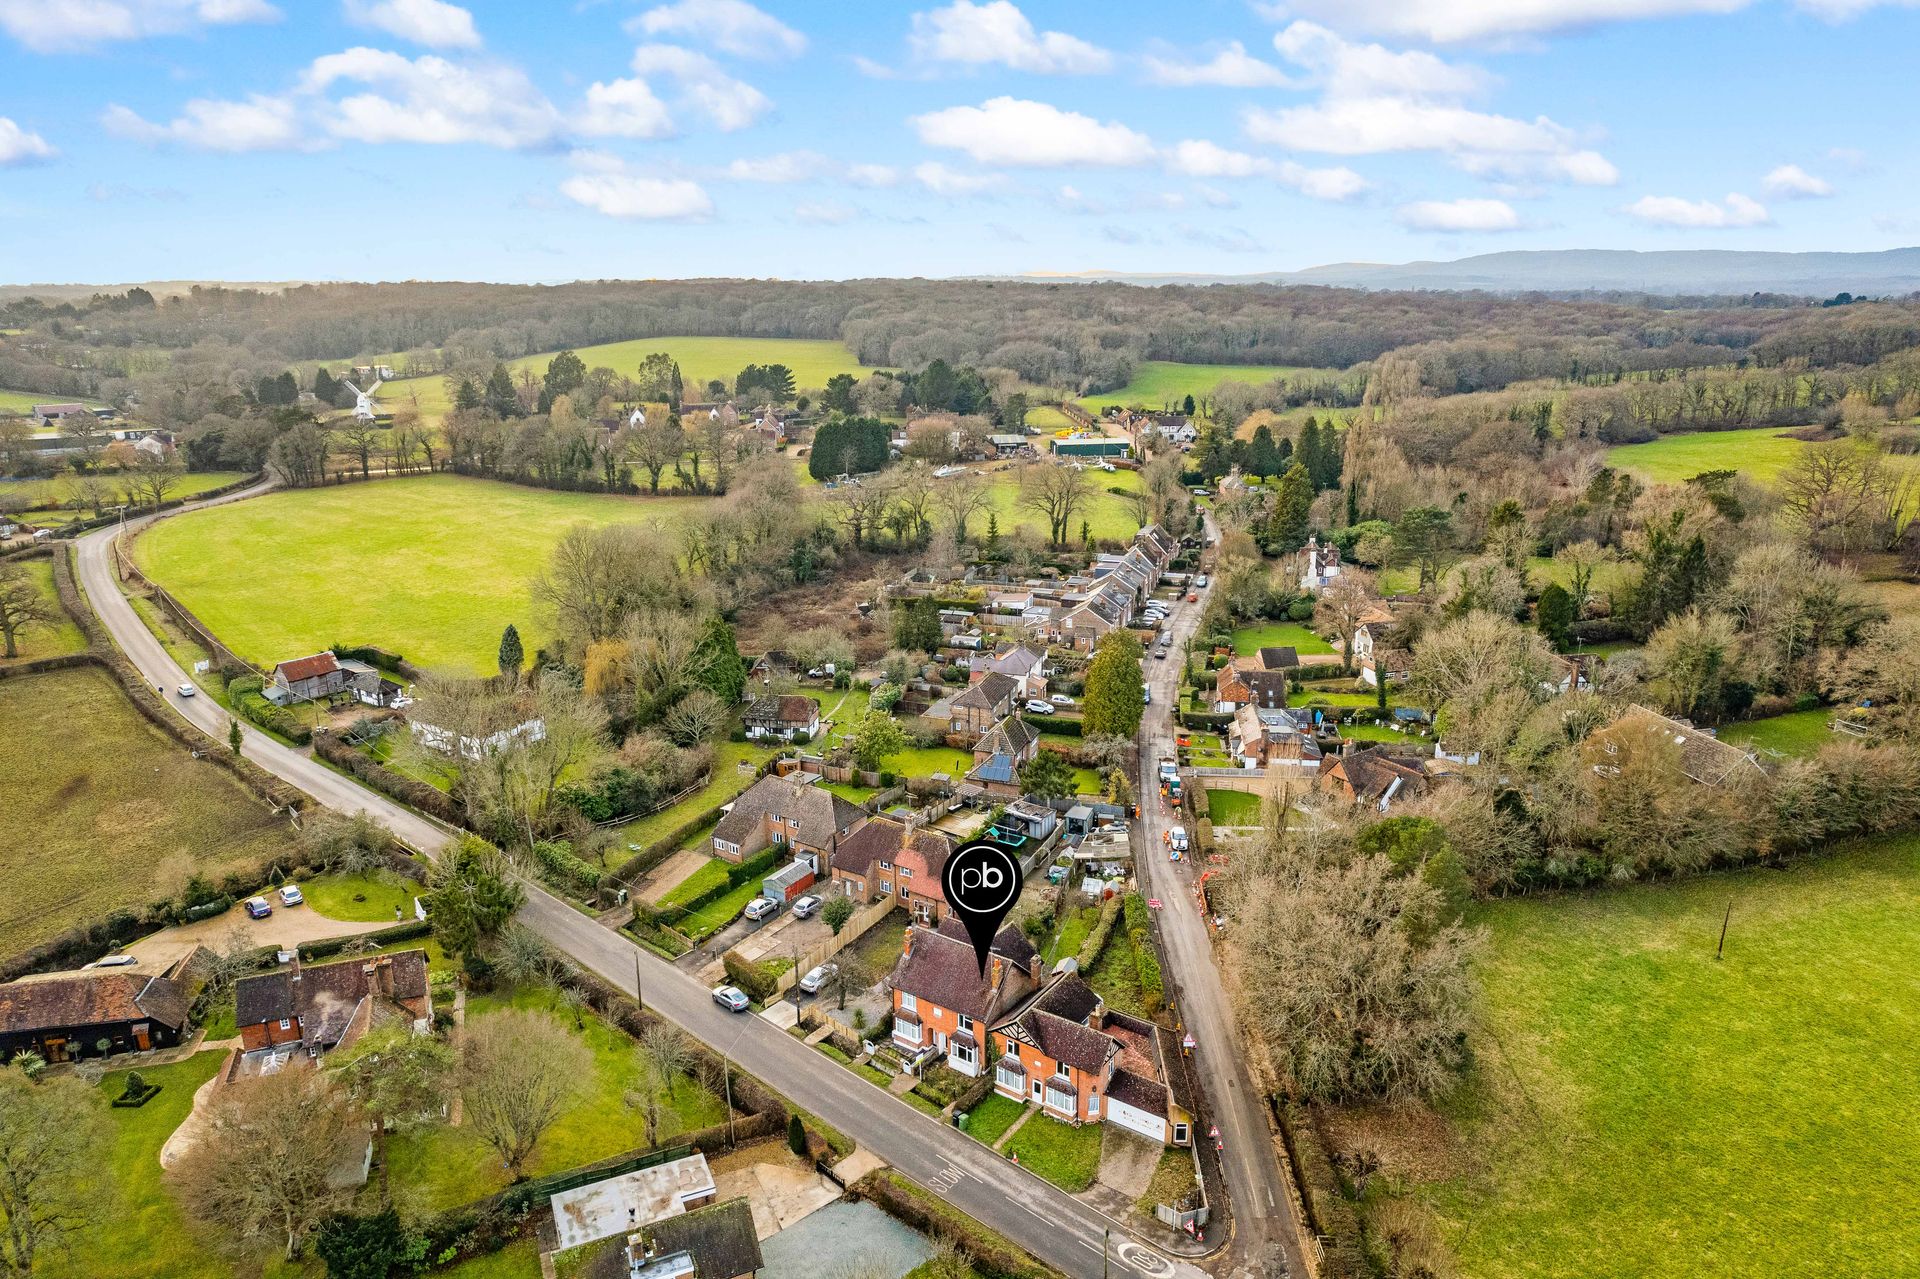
134, 474, 703, 674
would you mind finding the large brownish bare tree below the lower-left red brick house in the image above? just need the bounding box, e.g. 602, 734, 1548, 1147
171, 1070, 367, 1260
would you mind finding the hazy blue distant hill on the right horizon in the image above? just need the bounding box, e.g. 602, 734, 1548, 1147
1021, 248, 1920, 298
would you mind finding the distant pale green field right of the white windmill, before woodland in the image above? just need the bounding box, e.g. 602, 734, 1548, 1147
368, 338, 872, 417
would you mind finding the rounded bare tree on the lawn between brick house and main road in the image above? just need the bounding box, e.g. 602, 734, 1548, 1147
461, 1008, 593, 1173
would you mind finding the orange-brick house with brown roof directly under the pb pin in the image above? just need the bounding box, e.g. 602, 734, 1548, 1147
893, 918, 1041, 1075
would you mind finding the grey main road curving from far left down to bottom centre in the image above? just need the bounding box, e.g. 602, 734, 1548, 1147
77, 486, 1213, 1279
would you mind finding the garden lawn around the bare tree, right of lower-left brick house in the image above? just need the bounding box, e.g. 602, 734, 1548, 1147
388, 987, 726, 1212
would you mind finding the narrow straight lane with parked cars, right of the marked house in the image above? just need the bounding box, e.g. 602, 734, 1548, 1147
1133, 520, 1309, 1275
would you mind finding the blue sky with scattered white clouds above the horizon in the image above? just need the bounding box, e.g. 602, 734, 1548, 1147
0, 0, 1920, 282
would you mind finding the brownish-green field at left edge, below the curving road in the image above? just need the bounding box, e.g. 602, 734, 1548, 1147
0, 668, 292, 954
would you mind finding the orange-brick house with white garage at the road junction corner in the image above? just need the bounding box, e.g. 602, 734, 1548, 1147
989, 972, 1192, 1146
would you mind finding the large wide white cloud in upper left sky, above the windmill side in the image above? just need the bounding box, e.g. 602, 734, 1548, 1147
301, 48, 563, 148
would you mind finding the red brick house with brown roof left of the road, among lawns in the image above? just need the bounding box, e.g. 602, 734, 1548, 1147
234, 951, 434, 1056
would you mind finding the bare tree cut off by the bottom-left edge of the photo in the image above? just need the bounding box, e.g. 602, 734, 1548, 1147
0, 1062, 113, 1275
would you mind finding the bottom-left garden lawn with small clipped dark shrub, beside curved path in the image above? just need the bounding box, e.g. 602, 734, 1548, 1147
35, 1052, 234, 1279
